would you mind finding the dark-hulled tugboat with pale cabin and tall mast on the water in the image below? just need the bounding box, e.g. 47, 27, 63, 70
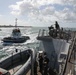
2, 19, 30, 43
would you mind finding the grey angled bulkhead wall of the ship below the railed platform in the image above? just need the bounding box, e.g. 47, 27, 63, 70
39, 38, 70, 71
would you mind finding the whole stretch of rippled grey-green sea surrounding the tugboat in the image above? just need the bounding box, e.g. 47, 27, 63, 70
0, 27, 47, 59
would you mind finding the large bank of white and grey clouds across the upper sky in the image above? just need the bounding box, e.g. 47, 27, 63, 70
9, 0, 76, 22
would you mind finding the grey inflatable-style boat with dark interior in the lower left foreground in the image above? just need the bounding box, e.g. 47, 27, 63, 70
0, 48, 36, 75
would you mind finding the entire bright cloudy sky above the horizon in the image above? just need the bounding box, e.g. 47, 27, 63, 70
0, 0, 76, 27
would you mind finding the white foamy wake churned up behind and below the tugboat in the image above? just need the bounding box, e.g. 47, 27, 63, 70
0, 28, 39, 58
